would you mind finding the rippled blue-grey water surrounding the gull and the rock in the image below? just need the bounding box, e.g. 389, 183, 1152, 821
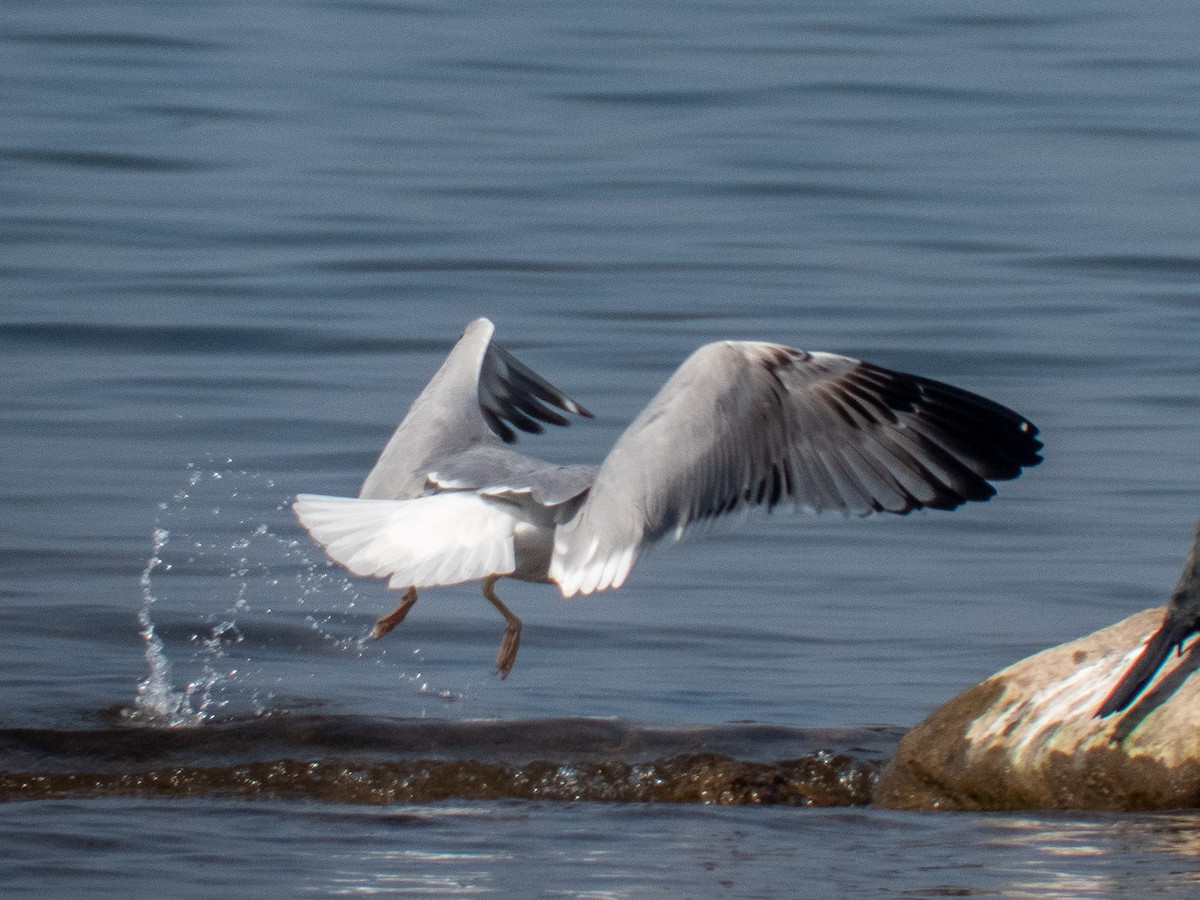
0, 0, 1200, 898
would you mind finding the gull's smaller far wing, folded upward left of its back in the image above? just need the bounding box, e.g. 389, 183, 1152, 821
359, 319, 592, 499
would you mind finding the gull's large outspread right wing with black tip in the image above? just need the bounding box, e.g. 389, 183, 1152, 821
550, 341, 1042, 596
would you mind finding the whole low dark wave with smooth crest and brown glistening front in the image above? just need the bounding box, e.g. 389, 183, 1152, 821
0, 708, 901, 806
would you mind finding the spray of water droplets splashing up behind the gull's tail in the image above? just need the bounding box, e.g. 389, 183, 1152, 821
124, 460, 462, 727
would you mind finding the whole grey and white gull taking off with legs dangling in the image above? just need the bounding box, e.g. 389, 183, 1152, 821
293, 318, 1042, 678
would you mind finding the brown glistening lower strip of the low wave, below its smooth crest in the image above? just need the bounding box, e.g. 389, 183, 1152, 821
0, 754, 877, 806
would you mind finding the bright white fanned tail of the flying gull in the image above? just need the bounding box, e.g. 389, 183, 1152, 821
292, 492, 516, 588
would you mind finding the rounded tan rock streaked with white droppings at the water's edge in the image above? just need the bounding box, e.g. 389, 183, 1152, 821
872, 609, 1200, 810
